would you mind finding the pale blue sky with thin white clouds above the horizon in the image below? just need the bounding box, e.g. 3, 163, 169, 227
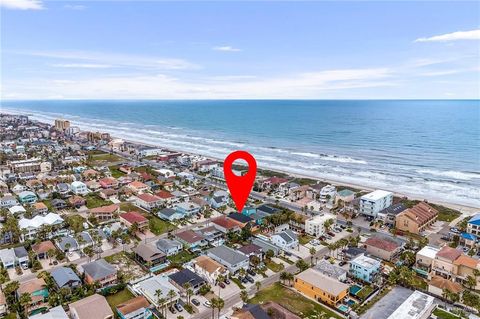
0, 0, 480, 100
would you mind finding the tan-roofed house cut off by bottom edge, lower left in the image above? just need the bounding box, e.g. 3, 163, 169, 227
68, 294, 114, 319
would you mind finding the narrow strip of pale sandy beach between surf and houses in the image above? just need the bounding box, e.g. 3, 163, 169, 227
19, 112, 480, 215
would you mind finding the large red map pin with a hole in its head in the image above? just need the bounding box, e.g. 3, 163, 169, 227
223, 151, 257, 213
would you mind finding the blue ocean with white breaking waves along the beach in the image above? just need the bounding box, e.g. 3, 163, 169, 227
1, 100, 480, 207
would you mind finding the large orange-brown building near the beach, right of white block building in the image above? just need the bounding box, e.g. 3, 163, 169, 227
395, 202, 438, 235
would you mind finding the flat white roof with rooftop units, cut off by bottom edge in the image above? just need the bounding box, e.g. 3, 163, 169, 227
388, 290, 435, 319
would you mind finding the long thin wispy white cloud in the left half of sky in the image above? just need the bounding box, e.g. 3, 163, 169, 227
17, 51, 200, 70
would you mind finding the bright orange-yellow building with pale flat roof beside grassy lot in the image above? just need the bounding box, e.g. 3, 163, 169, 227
294, 268, 349, 306
